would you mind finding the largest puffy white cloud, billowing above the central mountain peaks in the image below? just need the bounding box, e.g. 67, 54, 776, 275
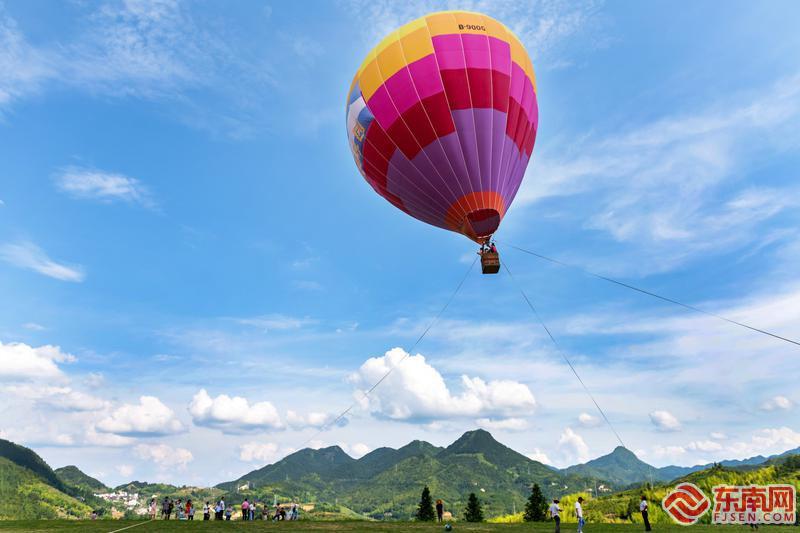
349, 348, 536, 421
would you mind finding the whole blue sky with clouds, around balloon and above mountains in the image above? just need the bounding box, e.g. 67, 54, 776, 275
0, 0, 800, 484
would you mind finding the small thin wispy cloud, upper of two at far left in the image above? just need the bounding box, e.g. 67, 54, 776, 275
55, 167, 155, 207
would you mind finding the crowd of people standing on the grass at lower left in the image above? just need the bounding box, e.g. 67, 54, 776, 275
148, 496, 300, 521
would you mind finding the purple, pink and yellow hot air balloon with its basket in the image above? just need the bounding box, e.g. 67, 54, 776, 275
347, 11, 539, 272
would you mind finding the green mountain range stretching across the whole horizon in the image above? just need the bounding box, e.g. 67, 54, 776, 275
0, 430, 800, 518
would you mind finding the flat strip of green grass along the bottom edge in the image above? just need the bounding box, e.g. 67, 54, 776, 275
0, 520, 780, 533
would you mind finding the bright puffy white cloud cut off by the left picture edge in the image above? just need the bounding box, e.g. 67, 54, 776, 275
0, 342, 75, 381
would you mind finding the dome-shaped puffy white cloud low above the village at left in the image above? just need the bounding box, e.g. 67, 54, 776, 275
97, 396, 184, 437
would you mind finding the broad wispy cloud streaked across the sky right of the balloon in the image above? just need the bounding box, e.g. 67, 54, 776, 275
516, 76, 800, 274
